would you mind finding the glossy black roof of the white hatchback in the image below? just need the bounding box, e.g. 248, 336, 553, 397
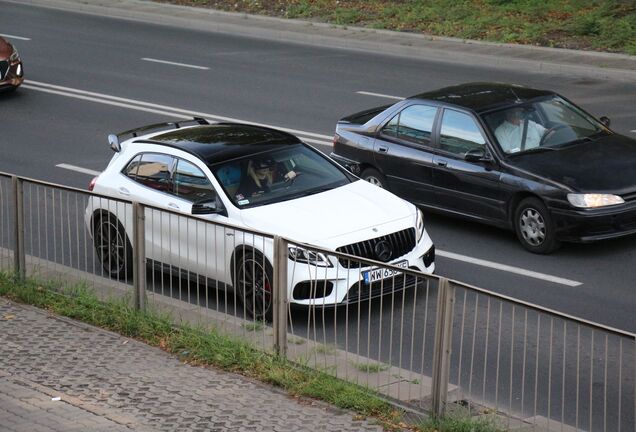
144, 123, 301, 165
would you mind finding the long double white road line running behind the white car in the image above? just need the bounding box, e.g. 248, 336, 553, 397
22, 80, 333, 146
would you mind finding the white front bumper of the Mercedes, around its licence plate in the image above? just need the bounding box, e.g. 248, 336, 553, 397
288, 233, 435, 306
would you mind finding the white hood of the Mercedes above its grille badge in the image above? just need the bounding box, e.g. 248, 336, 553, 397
241, 180, 415, 249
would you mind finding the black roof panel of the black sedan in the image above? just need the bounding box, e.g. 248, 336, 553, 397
409, 83, 554, 113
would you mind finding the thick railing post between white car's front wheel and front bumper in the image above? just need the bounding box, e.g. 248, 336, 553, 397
273, 236, 289, 357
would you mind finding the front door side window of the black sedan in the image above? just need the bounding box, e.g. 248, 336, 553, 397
439, 109, 486, 156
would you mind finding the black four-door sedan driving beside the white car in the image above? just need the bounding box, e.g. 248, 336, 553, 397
332, 83, 636, 253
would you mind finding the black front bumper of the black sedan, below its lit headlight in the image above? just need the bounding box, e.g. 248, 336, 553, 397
552, 202, 636, 243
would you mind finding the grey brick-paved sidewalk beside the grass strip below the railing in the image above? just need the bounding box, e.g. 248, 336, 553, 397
0, 297, 382, 432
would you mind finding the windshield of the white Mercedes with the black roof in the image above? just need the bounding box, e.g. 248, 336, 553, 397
210, 144, 352, 208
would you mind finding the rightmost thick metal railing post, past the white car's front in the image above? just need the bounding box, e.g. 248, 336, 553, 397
431, 278, 455, 417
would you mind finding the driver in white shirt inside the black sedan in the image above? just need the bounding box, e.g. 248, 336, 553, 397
495, 108, 546, 153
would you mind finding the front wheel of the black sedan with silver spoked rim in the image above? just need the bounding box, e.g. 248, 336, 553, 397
514, 198, 560, 254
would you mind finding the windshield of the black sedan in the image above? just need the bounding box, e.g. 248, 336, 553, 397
484, 96, 607, 154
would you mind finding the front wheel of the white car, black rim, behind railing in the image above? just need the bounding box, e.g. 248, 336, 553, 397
234, 251, 274, 322
